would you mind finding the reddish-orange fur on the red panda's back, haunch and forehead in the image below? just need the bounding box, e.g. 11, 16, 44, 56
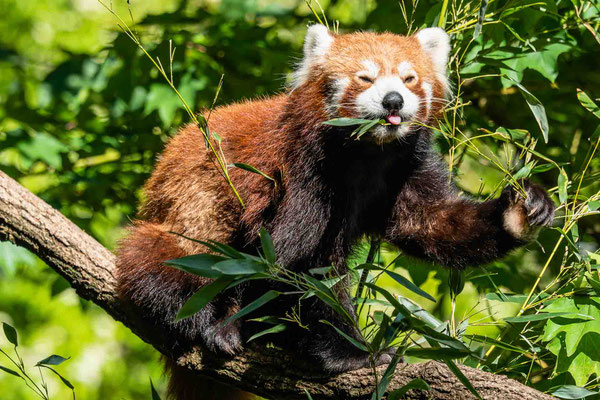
118, 28, 454, 400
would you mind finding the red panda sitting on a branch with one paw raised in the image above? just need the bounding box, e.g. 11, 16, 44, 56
118, 25, 554, 400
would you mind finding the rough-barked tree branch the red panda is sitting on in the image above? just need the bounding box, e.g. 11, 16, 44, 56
0, 171, 552, 400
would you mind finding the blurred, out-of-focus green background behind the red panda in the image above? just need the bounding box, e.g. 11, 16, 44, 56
0, 0, 600, 400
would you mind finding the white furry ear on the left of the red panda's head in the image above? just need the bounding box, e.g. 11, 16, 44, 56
292, 24, 333, 87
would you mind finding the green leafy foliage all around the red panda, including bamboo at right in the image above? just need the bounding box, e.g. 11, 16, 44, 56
0, 0, 600, 398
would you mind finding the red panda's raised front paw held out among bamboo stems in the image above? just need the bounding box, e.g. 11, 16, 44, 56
502, 180, 556, 240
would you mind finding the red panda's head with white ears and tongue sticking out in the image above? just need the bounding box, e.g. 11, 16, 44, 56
293, 25, 450, 143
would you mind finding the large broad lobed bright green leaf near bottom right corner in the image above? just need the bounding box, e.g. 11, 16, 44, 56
540, 296, 600, 386
